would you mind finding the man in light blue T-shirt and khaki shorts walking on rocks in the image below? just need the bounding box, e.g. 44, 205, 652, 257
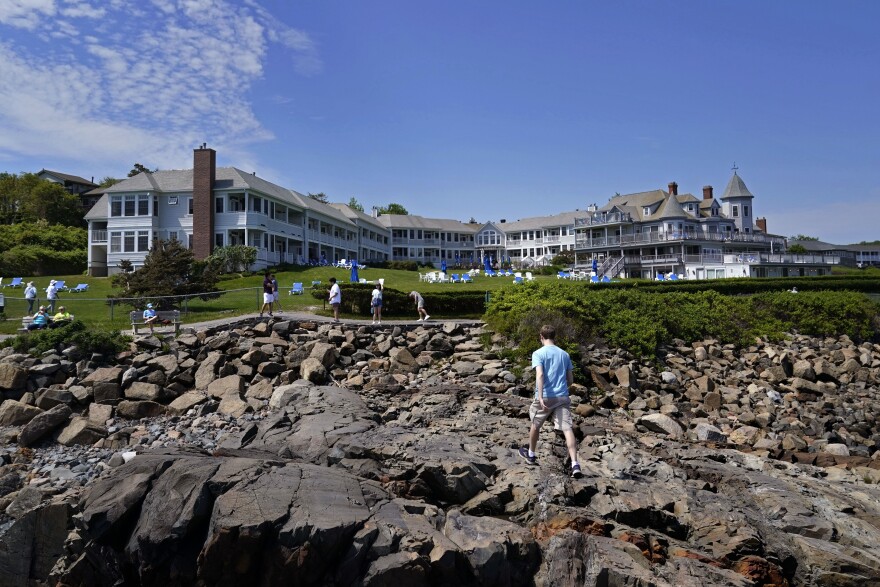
519, 325, 581, 478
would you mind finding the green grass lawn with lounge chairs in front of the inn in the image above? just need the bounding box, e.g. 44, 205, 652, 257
0, 267, 556, 334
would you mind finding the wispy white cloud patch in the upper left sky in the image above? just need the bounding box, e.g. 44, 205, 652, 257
0, 0, 321, 168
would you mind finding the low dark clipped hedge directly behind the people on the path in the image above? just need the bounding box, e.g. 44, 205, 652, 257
312, 283, 486, 317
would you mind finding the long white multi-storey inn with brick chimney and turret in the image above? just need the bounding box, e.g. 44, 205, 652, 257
86, 145, 856, 278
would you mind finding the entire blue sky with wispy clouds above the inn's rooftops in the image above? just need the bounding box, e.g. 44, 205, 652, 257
0, 0, 880, 243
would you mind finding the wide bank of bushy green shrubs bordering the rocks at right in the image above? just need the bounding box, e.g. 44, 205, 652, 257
485, 280, 880, 357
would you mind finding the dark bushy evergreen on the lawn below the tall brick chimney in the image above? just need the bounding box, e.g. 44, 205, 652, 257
112, 240, 220, 310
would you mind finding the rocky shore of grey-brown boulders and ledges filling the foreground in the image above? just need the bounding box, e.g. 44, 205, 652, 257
0, 320, 880, 586
